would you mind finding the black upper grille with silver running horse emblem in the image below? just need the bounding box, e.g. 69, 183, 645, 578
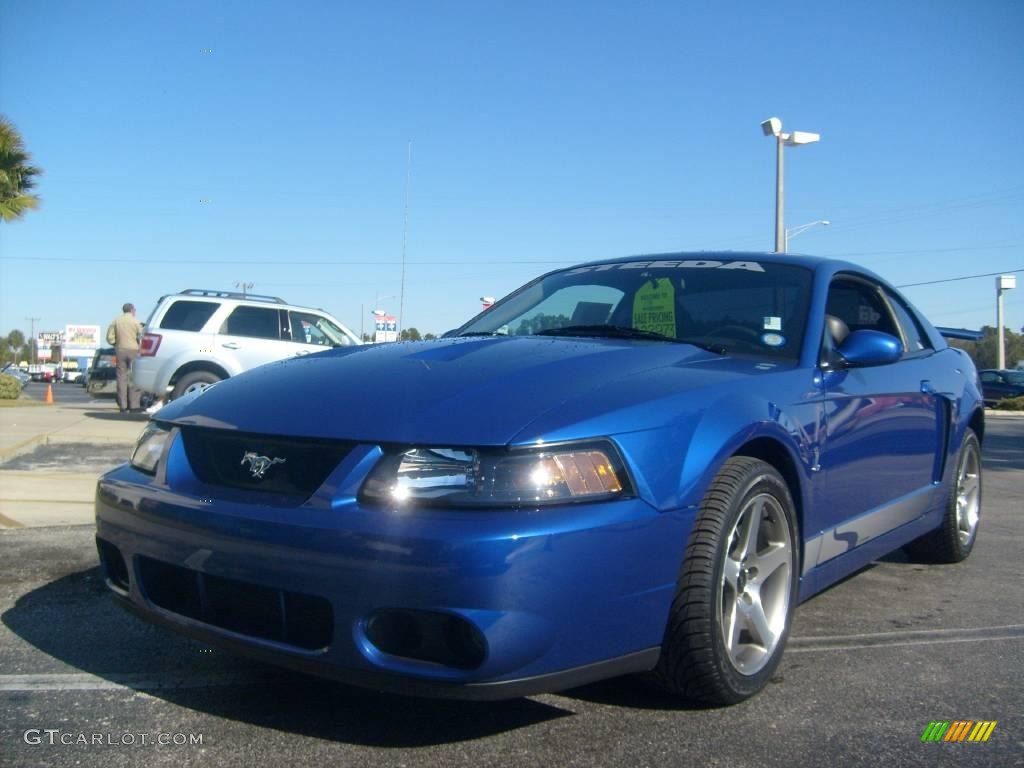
181, 427, 352, 499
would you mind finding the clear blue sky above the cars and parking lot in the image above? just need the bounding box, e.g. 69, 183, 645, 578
0, 0, 1024, 342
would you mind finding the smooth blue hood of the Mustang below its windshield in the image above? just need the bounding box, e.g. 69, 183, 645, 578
156, 337, 754, 445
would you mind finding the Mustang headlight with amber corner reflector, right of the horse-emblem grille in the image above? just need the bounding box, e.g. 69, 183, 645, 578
360, 442, 631, 507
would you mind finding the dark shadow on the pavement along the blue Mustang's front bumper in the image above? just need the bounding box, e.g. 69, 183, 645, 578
0, 566, 573, 748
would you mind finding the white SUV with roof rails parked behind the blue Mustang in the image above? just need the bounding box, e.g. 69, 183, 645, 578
132, 289, 359, 399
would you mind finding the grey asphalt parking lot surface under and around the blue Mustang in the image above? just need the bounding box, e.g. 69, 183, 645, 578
0, 417, 1024, 768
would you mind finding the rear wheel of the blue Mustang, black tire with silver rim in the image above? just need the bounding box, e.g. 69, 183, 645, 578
906, 427, 982, 563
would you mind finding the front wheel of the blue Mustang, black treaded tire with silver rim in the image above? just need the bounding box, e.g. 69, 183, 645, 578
654, 457, 800, 705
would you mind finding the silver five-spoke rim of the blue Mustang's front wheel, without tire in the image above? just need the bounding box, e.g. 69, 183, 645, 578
719, 494, 794, 675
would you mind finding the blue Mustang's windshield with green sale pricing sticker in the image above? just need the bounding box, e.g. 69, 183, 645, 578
456, 259, 812, 359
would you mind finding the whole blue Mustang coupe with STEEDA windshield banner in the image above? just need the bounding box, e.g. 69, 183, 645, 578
96, 253, 984, 703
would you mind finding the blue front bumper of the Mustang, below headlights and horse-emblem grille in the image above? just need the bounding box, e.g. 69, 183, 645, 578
96, 446, 693, 698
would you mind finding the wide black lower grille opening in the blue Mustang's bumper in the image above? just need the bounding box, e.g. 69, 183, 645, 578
138, 557, 334, 650
